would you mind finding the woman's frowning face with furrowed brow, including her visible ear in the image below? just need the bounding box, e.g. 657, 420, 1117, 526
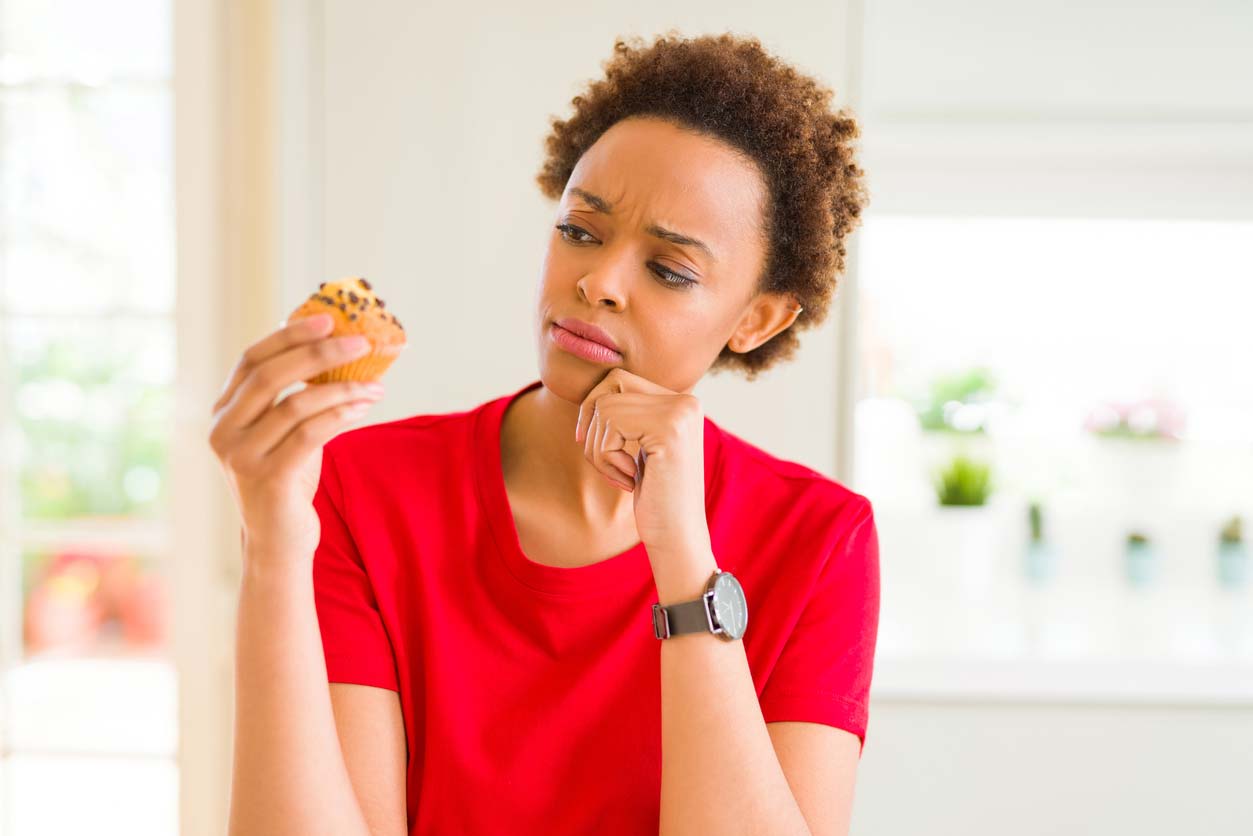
536, 118, 796, 392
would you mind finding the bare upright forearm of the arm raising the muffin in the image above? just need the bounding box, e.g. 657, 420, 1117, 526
229, 549, 370, 836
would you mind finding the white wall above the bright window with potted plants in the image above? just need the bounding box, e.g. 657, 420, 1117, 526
862, 0, 1253, 218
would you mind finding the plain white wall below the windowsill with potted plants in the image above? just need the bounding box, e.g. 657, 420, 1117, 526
852, 701, 1253, 836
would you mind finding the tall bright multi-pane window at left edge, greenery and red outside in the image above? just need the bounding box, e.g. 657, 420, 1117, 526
0, 0, 178, 836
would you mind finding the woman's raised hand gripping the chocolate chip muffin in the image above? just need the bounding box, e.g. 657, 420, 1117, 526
209, 315, 383, 569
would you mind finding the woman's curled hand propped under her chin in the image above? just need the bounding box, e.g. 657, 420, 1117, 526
574, 367, 709, 554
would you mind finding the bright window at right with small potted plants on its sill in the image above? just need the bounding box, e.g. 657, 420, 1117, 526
855, 217, 1253, 659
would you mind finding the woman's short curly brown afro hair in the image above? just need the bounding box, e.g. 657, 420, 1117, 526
535, 29, 867, 381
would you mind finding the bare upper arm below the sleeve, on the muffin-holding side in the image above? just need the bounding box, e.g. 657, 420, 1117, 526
331, 682, 408, 836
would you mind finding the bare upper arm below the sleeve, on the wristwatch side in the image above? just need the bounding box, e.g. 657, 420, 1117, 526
766, 721, 861, 836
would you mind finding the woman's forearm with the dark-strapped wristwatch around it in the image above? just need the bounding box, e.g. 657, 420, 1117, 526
650, 553, 809, 836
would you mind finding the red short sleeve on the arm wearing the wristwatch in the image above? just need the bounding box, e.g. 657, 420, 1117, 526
759, 498, 878, 750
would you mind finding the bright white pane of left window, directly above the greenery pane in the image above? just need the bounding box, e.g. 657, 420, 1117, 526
0, 85, 174, 313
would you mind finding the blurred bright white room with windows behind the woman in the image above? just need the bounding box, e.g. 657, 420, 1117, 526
0, 0, 1253, 836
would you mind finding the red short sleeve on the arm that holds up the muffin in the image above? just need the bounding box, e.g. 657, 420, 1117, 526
313, 449, 400, 691
